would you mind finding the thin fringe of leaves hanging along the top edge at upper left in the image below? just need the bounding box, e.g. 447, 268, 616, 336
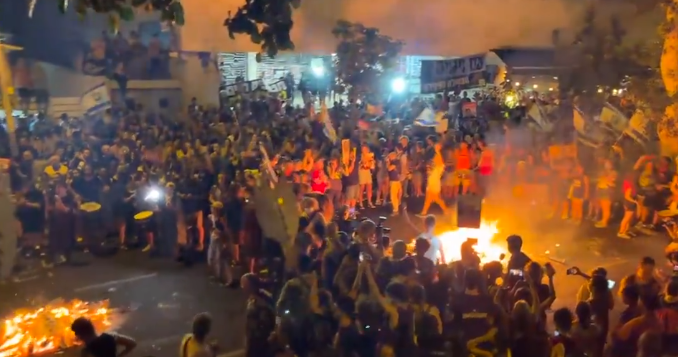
46, 0, 184, 32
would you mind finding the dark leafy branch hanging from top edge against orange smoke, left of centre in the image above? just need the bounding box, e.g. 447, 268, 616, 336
224, 0, 301, 60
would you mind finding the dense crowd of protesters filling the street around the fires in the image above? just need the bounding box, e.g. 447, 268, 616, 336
3, 84, 678, 357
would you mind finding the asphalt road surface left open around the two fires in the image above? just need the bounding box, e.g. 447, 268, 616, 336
0, 195, 666, 357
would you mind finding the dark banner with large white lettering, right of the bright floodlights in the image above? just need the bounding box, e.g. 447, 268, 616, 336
420, 54, 492, 94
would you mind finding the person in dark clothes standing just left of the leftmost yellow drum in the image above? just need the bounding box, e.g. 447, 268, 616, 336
48, 183, 77, 264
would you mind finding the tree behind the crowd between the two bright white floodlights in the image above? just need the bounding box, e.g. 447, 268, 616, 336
332, 20, 404, 96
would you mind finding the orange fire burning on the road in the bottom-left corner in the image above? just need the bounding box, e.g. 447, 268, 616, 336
0, 300, 111, 357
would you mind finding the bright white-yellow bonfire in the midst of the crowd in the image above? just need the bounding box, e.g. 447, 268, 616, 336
438, 220, 506, 264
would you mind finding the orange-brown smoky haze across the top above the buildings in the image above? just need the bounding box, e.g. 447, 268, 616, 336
181, 0, 660, 56
